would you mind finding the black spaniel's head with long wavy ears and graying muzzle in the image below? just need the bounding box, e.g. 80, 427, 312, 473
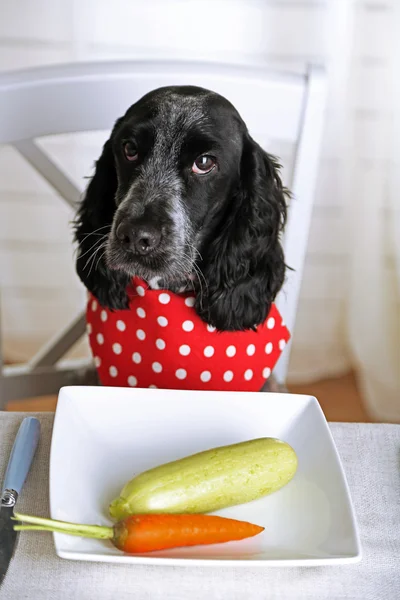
76, 87, 287, 331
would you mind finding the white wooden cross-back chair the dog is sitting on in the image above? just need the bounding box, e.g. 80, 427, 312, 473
0, 61, 326, 409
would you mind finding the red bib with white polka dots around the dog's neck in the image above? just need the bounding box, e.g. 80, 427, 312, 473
87, 278, 290, 391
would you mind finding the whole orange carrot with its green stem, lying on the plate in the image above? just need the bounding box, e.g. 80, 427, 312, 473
14, 513, 264, 554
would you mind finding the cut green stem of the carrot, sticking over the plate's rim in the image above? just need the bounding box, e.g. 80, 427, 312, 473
14, 513, 114, 540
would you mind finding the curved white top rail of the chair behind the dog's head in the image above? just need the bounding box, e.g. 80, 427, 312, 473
0, 62, 304, 144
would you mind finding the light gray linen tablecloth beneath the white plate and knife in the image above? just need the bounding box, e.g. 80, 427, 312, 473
0, 413, 400, 600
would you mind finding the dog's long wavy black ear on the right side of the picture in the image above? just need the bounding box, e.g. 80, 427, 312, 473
196, 136, 288, 331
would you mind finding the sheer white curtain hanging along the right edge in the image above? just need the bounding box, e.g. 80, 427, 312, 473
330, 1, 400, 421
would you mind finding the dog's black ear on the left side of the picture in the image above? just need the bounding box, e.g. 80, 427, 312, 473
75, 131, 129, 309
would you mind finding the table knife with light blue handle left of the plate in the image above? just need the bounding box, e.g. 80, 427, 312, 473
0, 417, 40, 585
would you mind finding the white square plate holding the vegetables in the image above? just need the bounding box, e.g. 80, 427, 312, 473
50, 387, 361, 566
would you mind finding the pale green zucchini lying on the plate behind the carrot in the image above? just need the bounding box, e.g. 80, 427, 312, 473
109, 438, 297, 521
